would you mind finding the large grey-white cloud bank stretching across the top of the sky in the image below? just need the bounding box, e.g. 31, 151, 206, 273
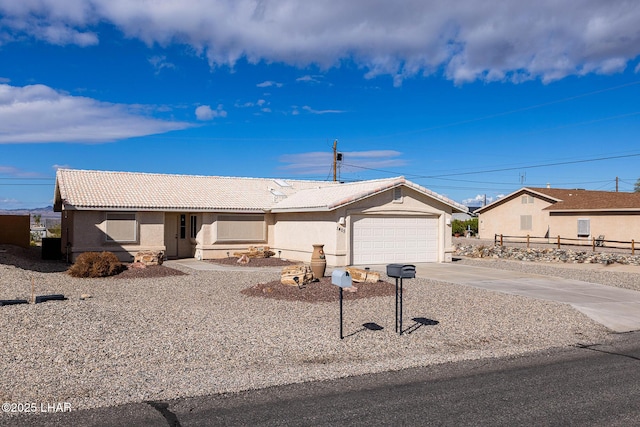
0, 0, 640, 87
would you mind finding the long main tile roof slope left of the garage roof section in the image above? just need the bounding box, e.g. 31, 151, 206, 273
56, 169, 333, 211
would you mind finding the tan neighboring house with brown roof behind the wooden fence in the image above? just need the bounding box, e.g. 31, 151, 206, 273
476, 187, 640, 242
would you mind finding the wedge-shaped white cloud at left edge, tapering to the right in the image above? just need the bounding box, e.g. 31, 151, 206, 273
0, 84, 192, 144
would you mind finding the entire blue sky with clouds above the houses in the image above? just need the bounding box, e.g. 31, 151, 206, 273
0, 0, 640, 209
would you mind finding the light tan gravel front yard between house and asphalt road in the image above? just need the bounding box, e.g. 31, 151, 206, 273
0, 246, 637, 416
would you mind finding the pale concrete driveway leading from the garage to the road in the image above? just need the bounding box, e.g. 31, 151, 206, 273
362, 263, 640, 332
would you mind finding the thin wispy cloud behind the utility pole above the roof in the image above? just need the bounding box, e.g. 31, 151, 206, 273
279, 150, 406, 175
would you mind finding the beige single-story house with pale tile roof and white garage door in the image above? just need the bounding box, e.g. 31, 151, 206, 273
54, 169, 467, 266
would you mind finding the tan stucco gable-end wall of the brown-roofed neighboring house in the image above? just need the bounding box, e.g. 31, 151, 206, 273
478, 196, 550, 239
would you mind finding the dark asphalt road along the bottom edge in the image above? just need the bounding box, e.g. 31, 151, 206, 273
6, 332, 640, 426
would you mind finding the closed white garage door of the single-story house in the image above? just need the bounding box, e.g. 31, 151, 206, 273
352, 216, 438, 265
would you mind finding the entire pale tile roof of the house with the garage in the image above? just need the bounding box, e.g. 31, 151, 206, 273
54, 169, 466, 212
